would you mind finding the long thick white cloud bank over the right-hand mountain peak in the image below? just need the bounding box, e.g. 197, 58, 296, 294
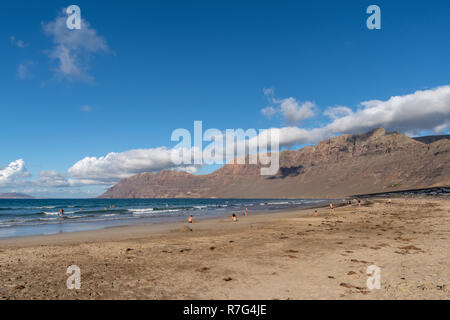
258, 85, 450, 146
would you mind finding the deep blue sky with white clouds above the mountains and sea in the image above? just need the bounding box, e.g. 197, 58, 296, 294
0, 0, 450, 197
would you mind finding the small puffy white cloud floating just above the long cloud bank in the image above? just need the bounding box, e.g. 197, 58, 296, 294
261, 88, 316, 125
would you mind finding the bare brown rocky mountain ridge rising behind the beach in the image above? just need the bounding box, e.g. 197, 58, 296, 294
101, 129, 450, 198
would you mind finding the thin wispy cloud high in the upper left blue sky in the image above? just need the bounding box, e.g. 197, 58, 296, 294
42, 10, 109, 82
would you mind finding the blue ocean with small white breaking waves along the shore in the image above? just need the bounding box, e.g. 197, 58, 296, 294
0, 199, 328, 238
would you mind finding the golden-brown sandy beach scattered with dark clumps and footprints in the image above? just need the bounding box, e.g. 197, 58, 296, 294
0, 197, 450, 299
